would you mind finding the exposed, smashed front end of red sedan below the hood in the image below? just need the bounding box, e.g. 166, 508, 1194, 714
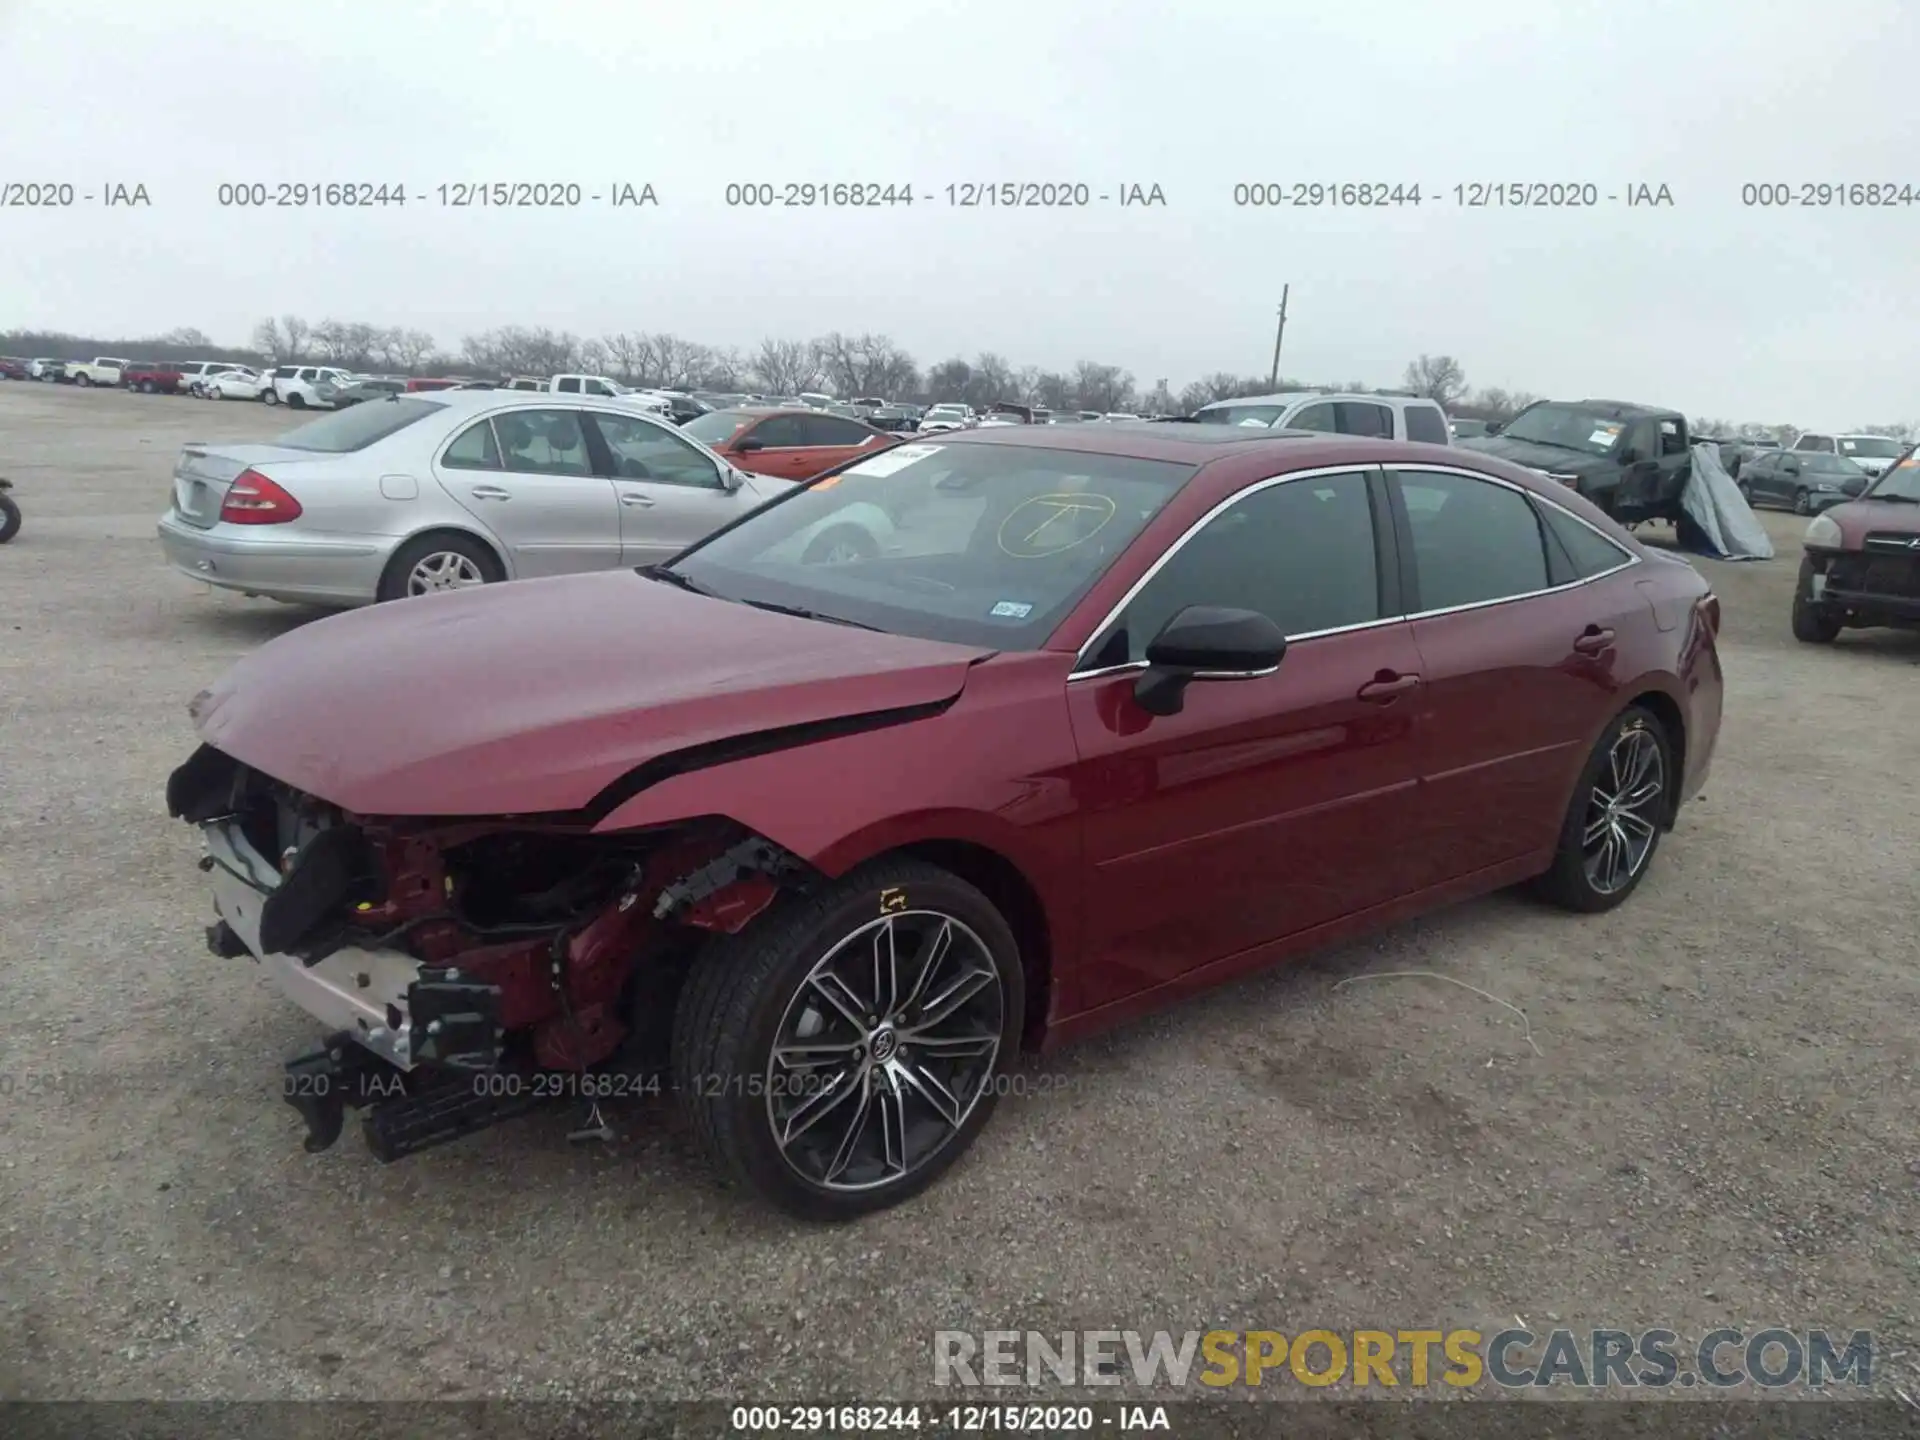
167, 745, 812, 1160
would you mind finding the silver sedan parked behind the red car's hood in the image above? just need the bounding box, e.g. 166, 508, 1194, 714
159, 390, 885, 605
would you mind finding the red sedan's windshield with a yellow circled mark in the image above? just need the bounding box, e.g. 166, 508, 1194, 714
670, 444, 1196, 649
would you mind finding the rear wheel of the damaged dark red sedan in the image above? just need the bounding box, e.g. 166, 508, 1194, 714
1536, 705, 1680, 914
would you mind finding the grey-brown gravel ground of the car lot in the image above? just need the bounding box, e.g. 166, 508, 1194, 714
0, 384, 1920, 1400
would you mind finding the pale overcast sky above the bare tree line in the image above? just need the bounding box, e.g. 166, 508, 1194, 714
0, 0, 1920, 426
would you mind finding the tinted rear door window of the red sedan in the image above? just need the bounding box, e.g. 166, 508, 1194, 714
1400, 470, 1548, 611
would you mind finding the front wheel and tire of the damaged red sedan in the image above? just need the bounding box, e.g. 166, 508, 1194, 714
672, 858, 1025, 1221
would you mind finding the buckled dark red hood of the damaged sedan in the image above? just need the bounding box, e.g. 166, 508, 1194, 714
192, 570, 993, 816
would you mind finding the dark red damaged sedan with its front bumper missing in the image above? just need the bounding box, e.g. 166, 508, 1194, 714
167, 426, 1722, 1217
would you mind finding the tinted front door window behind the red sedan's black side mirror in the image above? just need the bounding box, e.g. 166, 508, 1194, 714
1091, 474, 1380, 666
